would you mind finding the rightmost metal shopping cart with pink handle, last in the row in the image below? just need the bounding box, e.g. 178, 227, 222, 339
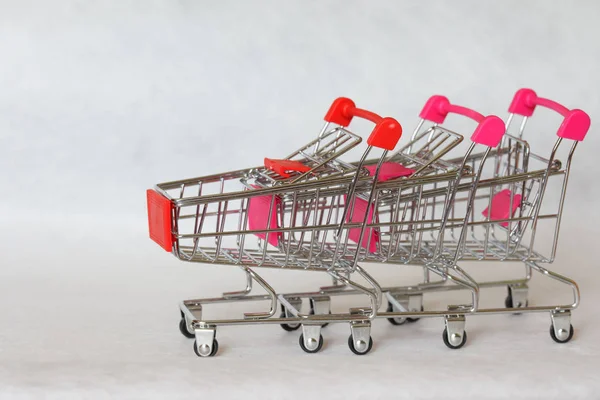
370, 89, 590, 348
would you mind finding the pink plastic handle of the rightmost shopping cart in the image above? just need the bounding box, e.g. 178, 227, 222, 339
508, 89, 591, 142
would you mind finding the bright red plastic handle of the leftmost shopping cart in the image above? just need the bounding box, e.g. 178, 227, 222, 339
325, 97, 402, 150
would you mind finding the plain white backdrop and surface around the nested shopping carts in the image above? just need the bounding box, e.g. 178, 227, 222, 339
0, 0, 600, 399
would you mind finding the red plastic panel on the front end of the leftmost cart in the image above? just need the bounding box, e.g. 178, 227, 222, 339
146, 189, 173, 253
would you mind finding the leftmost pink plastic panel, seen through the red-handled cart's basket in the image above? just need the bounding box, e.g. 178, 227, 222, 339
248, 185, 283, 247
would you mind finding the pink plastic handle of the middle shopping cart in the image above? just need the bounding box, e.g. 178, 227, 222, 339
419, 95, 506, 147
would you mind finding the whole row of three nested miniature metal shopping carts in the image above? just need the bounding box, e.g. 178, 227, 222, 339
148, 91, 589, 356
